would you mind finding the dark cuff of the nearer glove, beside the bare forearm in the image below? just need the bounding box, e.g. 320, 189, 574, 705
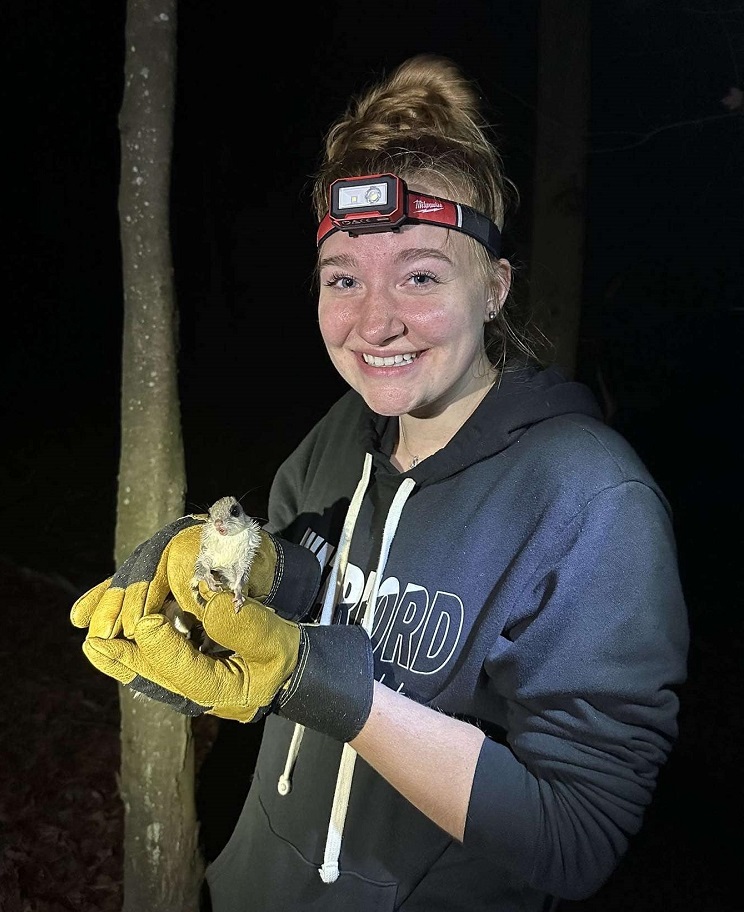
276, 624, 374, 741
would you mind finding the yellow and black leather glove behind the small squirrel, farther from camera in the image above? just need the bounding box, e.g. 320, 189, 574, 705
70, 515, 320, 639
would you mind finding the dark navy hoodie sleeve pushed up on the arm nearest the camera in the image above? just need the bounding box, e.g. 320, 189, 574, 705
465, 481, 688, 899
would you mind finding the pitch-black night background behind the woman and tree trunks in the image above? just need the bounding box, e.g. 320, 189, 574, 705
0, 0, 744, 912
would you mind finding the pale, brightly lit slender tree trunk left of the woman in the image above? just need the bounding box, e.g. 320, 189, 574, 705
114, 0, 203, 912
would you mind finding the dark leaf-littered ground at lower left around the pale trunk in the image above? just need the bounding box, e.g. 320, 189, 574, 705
0, 560, 217, 912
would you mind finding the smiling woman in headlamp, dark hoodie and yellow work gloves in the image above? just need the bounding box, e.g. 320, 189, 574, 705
73, 55, 687, 912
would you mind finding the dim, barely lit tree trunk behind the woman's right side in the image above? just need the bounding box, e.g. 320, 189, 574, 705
530, 0, 590, 377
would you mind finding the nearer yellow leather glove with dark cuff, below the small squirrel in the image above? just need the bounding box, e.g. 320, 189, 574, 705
83, 592, 374, 741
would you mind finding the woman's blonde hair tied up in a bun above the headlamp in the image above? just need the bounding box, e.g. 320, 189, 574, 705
312, 54, 548, 366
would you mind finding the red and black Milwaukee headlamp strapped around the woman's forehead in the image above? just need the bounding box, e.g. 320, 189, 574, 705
317, 174, 501, 257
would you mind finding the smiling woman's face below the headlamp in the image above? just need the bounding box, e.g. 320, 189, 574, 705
318, 225, 509, 418
